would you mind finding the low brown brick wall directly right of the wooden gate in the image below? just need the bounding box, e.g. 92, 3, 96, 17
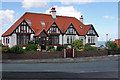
75, 50, 108, 57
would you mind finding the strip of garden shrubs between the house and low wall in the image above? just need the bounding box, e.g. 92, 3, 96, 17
0, 40, 120, 54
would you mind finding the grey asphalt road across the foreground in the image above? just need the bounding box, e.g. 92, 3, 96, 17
2, 61, 118, 79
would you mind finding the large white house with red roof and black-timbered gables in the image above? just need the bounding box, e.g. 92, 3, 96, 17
2, 7, 99, 49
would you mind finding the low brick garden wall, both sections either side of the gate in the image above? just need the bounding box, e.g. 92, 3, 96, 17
2, 51, 108, 59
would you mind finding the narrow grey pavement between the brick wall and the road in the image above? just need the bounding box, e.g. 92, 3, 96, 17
2, 55, 120, 64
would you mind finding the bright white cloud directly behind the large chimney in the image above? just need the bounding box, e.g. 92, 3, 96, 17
46, 6, 81, 19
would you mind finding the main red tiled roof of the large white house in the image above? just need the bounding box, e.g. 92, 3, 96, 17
2, 12, 95, 36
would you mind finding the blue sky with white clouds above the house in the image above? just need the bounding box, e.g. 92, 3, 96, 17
0, 0, 118, 41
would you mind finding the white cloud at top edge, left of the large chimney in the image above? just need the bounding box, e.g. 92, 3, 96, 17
22, 0, 49, 9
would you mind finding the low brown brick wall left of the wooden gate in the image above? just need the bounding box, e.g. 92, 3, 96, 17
2, 52, 63, 59
